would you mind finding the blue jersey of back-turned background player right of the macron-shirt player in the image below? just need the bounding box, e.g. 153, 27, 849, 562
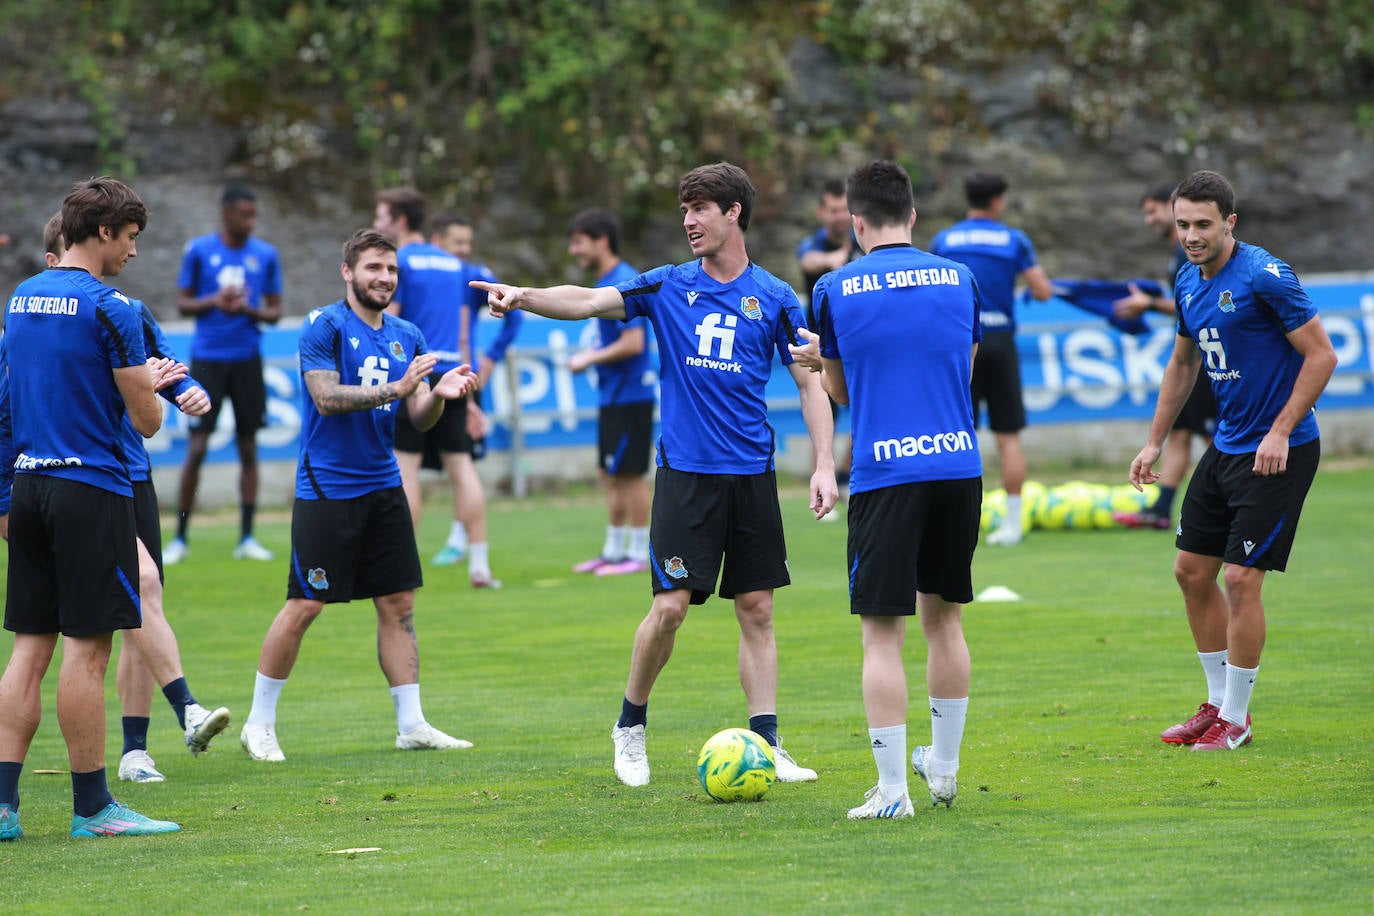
930, 217, 1036, 334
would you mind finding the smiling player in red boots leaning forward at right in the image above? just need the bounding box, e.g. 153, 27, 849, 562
1131, 172, 1336, 751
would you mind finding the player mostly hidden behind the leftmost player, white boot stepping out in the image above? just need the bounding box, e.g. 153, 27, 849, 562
10, 213, 229, 783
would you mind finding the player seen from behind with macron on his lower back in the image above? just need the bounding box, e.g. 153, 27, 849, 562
793, 161, 982, 820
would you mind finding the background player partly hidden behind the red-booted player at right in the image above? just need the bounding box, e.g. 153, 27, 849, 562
1112, 184, 1216, 531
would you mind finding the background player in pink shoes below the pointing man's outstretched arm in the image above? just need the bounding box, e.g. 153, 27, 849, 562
563, 210, 658, 575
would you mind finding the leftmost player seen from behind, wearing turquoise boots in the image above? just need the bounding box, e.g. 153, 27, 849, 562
0, 177, 185, 840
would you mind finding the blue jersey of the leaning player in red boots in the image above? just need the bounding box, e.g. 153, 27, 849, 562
1173, 242, 1319, 455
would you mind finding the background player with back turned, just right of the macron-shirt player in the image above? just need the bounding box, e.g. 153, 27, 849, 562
930, 172, 1054, 547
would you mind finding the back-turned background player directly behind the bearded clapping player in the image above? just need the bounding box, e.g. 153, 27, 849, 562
372, 188, 502, 588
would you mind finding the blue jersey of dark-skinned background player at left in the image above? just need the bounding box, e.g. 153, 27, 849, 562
176, 233, 282, 363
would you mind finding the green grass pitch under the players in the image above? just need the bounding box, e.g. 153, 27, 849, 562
0, 469, 1374, 913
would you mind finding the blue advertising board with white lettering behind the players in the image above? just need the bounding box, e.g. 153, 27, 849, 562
148, 273, 1374, 466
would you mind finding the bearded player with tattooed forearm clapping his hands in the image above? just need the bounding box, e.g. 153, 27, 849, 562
239, 229, 475, 761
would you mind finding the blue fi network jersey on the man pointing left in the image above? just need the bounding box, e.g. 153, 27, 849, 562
616, 260, 805, 474
